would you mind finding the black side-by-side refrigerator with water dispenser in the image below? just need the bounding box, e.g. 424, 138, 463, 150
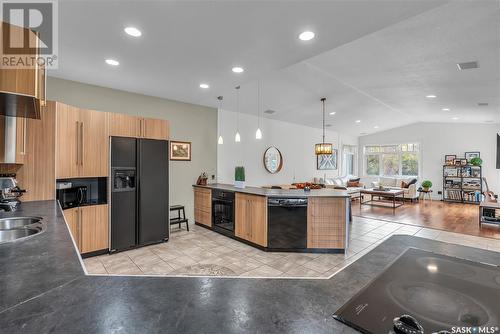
109, 137, 169, 251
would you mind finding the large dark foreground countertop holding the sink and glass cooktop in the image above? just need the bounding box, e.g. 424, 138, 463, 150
0, 201, 500, 333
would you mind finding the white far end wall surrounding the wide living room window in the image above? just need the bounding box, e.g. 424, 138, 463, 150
359, 123, 500, 198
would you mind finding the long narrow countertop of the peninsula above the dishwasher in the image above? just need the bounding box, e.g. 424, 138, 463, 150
193, 183, 349, 198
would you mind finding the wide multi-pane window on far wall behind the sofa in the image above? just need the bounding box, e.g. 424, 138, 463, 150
364, 143, 420, 176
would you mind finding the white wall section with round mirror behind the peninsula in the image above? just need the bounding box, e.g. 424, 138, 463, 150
217, 110, 357, 186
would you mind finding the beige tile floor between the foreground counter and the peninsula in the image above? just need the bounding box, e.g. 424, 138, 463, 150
84, 217, 500, 278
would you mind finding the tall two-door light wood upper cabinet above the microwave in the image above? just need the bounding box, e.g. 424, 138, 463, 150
56, 103, 109, 179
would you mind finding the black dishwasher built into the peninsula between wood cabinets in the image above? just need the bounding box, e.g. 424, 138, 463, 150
267, 197, 307, 250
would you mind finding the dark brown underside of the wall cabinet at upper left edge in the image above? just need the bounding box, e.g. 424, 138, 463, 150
0, 92, 40, 119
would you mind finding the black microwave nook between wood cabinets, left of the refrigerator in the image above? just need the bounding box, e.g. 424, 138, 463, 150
56, 177, 107, 210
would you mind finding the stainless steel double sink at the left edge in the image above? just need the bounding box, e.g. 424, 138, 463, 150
0, 217, 43, 244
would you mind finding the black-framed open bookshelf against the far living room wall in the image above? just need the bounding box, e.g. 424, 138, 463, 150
443, 165, 483, 204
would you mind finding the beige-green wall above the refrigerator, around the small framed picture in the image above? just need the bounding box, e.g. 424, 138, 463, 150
47, 77, 217, 222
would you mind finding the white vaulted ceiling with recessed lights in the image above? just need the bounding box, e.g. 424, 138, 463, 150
49, 0, 500, 135
